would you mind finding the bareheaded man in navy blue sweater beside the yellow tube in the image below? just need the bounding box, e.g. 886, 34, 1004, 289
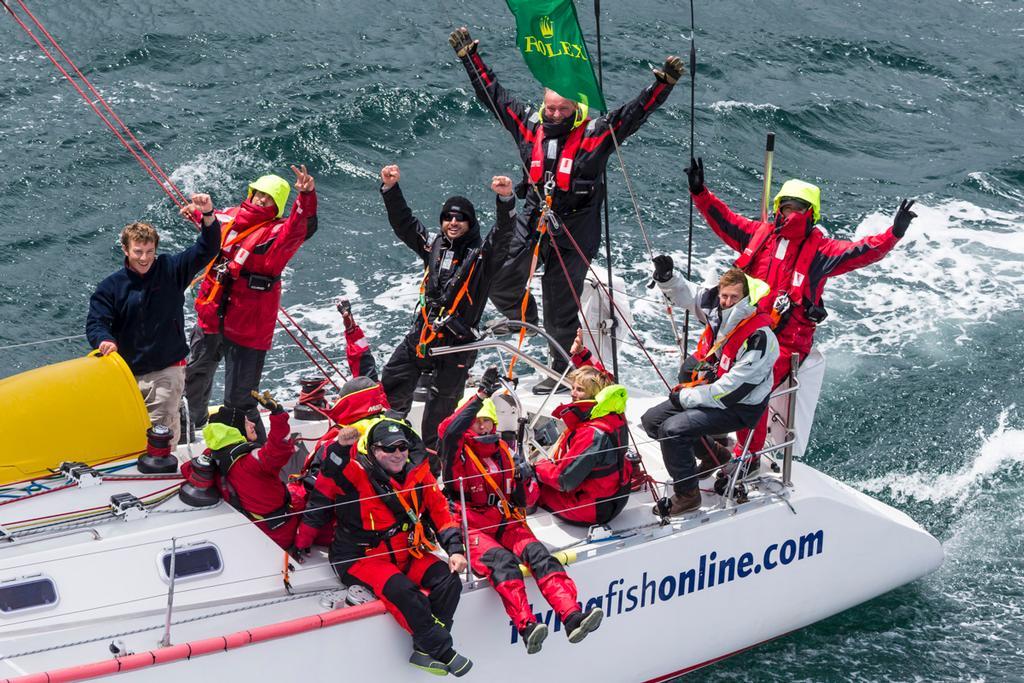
85, 195, 220, 443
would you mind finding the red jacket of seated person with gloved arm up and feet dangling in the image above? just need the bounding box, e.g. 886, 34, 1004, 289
437, 395, 539, 536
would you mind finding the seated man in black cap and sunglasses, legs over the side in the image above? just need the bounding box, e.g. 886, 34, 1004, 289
294, 418, 473, 676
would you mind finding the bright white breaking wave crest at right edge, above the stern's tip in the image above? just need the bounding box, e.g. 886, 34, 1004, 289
851, 405, 1024, 507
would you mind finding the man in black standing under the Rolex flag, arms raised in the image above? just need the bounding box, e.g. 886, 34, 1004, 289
449, 28, 683, 393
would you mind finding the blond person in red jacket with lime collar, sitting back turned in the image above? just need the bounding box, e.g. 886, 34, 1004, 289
537, 337, 633, 526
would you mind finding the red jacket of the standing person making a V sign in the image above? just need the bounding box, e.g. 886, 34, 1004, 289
196, 190, 316, 351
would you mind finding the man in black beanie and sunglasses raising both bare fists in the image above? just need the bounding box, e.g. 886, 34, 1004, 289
381, 165, 516, 464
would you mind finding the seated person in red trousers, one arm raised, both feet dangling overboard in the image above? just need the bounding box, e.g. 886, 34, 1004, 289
438, 368, 604, 654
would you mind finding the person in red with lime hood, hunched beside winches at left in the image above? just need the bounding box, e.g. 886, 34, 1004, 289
181, 391, 299, 549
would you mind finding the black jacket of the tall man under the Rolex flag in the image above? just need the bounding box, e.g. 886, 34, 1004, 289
462, 52, 672, 259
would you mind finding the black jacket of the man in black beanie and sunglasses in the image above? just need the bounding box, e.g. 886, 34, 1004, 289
381, 185, 516, 343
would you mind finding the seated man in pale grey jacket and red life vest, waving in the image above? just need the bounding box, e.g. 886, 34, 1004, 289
641, 264, 778, 515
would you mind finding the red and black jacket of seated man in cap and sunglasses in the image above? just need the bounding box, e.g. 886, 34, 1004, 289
295, 442, 465, 573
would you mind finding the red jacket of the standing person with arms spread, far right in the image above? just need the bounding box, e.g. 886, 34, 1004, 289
693, 189, 899, 358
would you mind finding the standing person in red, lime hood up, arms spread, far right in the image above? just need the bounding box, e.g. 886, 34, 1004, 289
686, 159, 918, 454
